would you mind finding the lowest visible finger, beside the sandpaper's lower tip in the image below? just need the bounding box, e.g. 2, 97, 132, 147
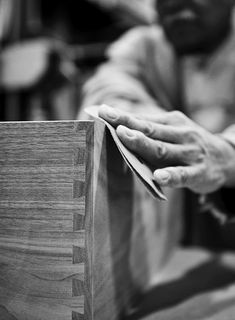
154, 165, 203, 192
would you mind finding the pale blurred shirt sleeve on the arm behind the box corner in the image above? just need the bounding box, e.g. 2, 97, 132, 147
79, 27, 165, 118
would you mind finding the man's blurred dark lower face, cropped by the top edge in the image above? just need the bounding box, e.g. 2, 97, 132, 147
156, 0, 234, 54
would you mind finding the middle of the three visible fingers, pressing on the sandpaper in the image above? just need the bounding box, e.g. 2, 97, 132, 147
117, 126, 198, 168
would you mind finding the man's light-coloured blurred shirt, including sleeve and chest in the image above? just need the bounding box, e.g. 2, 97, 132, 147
80, 26, 235, 144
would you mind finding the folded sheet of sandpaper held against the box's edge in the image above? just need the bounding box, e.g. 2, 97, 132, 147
85, 106, 167, 200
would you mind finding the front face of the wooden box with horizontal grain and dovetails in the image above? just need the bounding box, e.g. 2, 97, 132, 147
0, 121, 93, 320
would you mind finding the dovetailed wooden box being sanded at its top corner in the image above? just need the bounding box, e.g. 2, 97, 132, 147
0, 121, 183, 320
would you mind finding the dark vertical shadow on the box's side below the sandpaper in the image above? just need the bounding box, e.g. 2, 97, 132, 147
106, 132, 139, 319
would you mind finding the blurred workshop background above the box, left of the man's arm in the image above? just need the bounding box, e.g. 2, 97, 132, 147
0, 0, 155, 121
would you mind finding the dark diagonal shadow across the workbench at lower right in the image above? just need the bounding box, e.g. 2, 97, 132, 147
128, 258, 235, 320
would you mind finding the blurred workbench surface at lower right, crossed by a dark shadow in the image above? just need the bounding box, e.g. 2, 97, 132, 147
131, 249, 235, 320
